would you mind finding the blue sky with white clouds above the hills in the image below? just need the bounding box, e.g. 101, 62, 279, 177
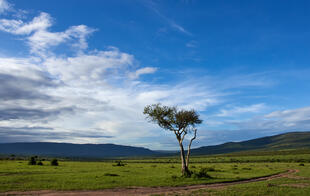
0, 0, 310, 150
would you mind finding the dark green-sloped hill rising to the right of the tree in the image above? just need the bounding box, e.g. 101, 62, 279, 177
191, 132, 310, 155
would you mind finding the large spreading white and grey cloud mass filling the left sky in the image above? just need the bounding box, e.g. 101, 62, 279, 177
0, 9, 217, 147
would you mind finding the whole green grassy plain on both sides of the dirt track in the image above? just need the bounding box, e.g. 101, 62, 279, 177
0, 150, 310, 195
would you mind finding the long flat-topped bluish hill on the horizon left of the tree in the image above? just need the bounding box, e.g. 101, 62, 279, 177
0, 142, 158, 158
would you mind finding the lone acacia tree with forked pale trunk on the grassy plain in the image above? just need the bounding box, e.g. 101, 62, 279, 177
143, 103, 202, 176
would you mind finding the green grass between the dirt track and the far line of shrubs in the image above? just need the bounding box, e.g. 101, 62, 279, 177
0, 161, 286, 192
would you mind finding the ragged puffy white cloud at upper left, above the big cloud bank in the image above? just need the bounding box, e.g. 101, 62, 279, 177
0, 12, 94, 56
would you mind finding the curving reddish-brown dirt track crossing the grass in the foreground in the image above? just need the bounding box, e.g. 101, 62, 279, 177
0, 169, 299, 196
